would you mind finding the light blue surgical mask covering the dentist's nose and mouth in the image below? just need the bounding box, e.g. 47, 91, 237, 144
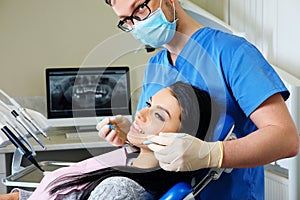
131, 0, 177, 48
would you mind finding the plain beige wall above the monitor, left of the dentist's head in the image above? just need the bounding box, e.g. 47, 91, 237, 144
0, 0, 149, 96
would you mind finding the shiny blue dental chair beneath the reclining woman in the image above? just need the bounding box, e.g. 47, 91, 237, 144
160, 115, 236, 200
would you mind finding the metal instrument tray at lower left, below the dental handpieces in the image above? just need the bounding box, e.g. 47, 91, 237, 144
2, 161, 73, 188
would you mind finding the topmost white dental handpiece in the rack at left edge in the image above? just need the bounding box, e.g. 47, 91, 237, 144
0, 89, 49, 139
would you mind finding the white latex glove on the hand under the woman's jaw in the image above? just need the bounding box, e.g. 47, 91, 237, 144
148, 133, 223, 171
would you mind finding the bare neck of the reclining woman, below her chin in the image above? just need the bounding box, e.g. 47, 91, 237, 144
132, 148, 158, 168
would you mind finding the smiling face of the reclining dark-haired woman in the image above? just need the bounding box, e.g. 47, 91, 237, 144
127, 88, 181, 146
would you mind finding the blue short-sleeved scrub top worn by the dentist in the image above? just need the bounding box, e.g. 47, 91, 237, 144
137, 28, 289, 200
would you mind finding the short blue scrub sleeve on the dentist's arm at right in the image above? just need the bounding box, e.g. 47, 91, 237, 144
224, 41, 289, 116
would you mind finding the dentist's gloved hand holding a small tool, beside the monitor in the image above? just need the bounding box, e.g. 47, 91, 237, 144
96, 115, 131, 146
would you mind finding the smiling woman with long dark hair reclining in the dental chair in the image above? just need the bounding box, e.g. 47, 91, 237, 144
0, 82, 211, 200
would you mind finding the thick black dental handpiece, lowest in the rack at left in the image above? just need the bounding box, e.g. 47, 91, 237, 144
0, 122, 44, 172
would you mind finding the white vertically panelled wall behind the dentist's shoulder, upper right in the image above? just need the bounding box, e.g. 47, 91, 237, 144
229, 0, 300, 78
